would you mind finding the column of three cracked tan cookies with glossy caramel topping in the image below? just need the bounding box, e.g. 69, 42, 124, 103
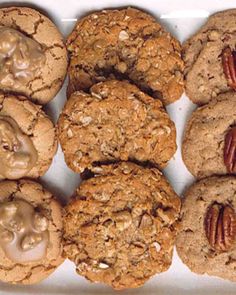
0, 7, 67, 284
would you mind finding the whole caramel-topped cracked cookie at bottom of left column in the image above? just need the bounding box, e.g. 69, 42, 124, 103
0, 180, 64, 284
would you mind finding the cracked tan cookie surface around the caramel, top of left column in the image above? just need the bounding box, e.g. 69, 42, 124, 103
0, 7, 67, 104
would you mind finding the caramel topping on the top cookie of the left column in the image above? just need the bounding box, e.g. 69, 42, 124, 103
0, 27, 46, 89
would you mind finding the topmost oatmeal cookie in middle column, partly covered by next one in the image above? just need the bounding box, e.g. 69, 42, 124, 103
67, 8, 184, 105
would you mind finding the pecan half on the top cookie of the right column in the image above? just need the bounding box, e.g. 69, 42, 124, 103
222, 46, 236, 90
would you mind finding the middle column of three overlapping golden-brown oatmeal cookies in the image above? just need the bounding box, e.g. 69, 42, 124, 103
58, 8, 183, 289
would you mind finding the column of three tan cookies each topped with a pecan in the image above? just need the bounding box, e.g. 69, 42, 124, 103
177, 10, 236, 281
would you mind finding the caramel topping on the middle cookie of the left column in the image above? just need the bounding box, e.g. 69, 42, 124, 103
0, 115, 38, 179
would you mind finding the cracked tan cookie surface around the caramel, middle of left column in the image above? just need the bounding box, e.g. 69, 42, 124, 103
0, 93, 57, 179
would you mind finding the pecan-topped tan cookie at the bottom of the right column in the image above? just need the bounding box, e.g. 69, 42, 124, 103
176, 176, 236, 281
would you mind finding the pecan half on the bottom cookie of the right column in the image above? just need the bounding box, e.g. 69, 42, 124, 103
205, 203, 236, 251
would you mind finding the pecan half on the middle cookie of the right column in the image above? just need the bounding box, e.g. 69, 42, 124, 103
224, 126, 236, 173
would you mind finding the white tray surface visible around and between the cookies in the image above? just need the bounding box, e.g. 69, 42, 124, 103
0, 0, 236, 295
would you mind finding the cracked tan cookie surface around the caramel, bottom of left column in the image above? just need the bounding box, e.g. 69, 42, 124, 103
0, 180, 63, 284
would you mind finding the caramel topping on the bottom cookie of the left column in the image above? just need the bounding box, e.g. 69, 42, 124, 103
0, 200, 49, 263
